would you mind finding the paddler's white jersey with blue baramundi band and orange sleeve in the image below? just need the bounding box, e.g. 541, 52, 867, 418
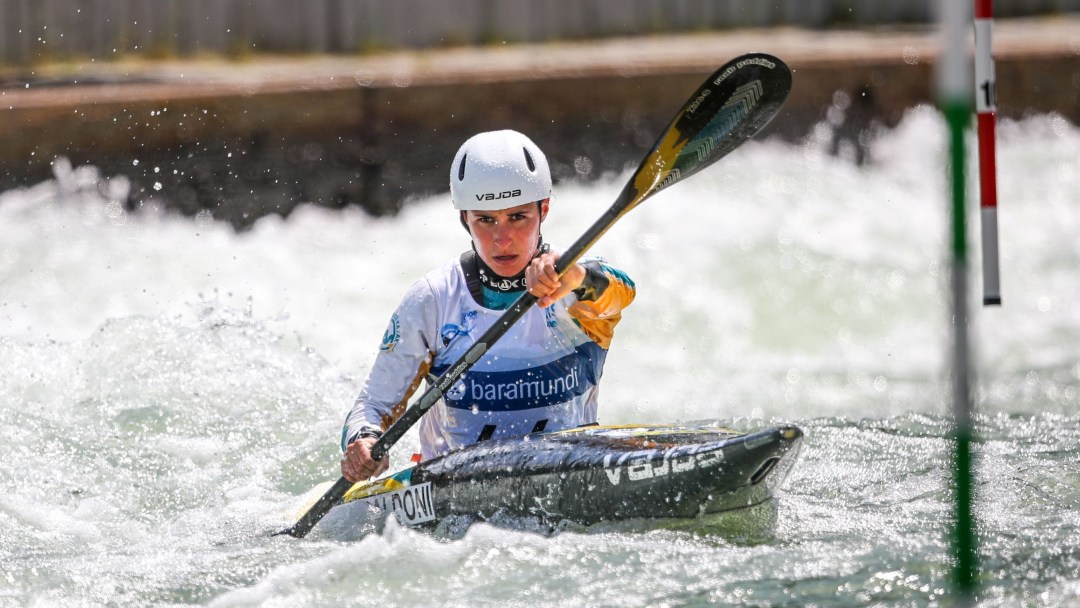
341, 252, 635, 460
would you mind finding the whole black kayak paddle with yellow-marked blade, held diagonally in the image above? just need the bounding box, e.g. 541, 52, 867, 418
274, 53, 792, 538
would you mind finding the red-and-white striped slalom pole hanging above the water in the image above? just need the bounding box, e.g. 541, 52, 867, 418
974, 0, 1001, 306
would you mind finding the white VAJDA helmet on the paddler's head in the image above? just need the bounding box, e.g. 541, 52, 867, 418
450, 130, 551, 211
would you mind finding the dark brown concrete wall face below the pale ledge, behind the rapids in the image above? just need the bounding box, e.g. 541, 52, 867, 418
6, 45, 1080, 228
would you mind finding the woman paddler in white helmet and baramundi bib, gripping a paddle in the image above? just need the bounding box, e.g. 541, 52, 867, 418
341, 131, 634, 482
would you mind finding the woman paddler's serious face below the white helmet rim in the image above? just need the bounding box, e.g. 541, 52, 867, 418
465, 199, 548, 276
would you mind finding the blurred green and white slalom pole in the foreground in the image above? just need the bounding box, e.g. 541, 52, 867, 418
937, 0, 978, 606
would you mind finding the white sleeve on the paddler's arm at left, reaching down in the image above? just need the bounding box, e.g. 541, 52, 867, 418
341, 280, 438, 450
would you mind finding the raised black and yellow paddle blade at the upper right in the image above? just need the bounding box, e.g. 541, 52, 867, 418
625, 53, 792, 211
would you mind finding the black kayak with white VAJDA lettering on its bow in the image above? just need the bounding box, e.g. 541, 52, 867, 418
311, 424, 802, 533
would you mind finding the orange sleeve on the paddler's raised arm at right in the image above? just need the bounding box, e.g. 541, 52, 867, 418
569, 259, 637, 349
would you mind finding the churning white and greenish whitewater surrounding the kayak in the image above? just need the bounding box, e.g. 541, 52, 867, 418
0, 109, 1080, 607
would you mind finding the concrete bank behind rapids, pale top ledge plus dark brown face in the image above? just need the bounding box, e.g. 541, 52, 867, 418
0, 10, 1080, 227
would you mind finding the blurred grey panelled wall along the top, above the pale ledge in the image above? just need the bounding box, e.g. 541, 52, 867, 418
0, 0, 1080, 65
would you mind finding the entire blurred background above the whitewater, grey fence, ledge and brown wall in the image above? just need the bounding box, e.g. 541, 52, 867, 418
0, 0, 1080, 229
